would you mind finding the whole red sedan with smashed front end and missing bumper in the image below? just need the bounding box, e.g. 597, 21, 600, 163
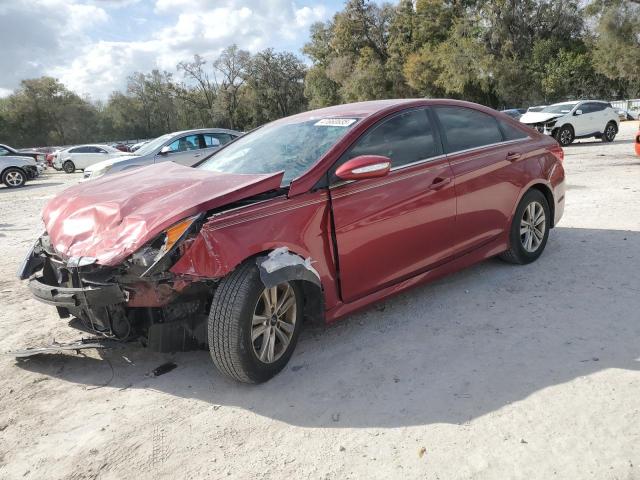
19, 100, 565, 382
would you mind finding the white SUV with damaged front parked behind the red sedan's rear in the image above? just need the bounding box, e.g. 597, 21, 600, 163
520, 100, 619, 147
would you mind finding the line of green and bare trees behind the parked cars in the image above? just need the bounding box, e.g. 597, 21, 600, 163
0, 0, 640, 146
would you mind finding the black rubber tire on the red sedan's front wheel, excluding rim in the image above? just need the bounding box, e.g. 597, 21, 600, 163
208, 260, 303, 383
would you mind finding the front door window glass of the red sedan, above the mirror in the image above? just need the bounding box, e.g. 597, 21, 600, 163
336, 109, 442, 172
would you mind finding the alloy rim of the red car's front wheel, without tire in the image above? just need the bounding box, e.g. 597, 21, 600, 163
251, 283, 298, 363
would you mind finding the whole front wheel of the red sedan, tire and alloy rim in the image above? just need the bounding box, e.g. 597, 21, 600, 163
208, 262, 303, 383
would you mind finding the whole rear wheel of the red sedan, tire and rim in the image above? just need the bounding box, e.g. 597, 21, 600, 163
500, 190, 551, 265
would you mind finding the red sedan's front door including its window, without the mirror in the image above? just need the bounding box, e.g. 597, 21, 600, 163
329, 108, 456, 302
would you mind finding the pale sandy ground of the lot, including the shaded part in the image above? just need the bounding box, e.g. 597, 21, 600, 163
0, 122, 640, 480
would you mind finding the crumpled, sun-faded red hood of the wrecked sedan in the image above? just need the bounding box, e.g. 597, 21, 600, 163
42, 162, 282, 265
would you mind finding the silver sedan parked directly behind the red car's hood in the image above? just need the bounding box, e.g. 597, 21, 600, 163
84, 128, 242, 179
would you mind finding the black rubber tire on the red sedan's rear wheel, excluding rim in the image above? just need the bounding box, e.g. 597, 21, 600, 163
500, 189, 551, 265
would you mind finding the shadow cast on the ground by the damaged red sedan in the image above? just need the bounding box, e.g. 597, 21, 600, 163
17, 228, 640, 428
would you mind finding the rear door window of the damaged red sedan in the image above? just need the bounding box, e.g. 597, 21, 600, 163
435, 107, 503, 153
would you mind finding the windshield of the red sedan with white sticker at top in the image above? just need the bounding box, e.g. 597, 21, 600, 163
198, 118, 358, 186
